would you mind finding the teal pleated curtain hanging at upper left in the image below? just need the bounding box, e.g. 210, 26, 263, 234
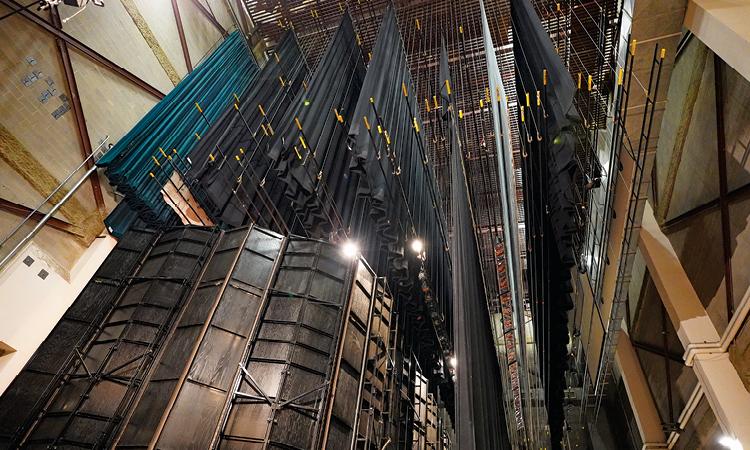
97, 31, 259, 223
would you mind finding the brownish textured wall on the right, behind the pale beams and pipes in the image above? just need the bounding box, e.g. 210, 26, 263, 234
630, 29, 750, 448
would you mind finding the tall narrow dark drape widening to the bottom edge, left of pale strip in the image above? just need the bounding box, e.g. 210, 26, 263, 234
444, 35, 510, 450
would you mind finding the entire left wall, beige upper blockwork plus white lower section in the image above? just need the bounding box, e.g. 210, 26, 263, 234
0, 0, 253, 392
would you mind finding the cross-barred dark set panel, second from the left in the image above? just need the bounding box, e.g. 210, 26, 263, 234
16, 228, 215, 447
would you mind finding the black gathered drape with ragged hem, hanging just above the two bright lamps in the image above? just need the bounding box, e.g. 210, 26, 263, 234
349, 7, 453, 369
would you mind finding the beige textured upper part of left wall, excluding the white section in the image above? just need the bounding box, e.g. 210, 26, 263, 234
0, 0, 242, 270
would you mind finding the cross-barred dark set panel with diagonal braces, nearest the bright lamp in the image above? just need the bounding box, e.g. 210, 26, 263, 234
218, 237, 354, 449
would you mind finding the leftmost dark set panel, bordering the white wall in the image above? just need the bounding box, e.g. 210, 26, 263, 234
0, 229, 158, 447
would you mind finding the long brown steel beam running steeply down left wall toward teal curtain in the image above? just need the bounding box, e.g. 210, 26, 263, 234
50, 7, 106, 212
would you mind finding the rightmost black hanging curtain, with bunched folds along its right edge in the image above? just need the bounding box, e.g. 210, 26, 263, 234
511, 0, 582, 449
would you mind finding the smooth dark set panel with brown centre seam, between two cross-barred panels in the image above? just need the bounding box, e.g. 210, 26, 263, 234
117, 227, 282, 448
